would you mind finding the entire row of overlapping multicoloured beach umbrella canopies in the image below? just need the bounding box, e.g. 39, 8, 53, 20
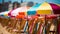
0, 2, 60, 18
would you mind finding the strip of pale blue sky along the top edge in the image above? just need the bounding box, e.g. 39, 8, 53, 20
0, 0, 60, 4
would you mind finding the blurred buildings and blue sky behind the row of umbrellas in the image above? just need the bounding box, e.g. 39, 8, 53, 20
0, 0, 60, 12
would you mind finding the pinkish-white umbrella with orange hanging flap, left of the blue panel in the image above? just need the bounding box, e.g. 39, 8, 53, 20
10, 6, 29, 18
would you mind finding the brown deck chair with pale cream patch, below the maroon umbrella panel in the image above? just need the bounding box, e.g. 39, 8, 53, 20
47, 16, 57, 34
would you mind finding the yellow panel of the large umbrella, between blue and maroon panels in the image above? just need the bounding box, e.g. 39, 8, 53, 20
37, 2, 53, 14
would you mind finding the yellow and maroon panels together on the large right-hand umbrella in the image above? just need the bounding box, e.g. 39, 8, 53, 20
37, 2, 60, 14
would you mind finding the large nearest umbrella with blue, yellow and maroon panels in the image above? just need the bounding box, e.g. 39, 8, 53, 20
27, 2, 60, 15
